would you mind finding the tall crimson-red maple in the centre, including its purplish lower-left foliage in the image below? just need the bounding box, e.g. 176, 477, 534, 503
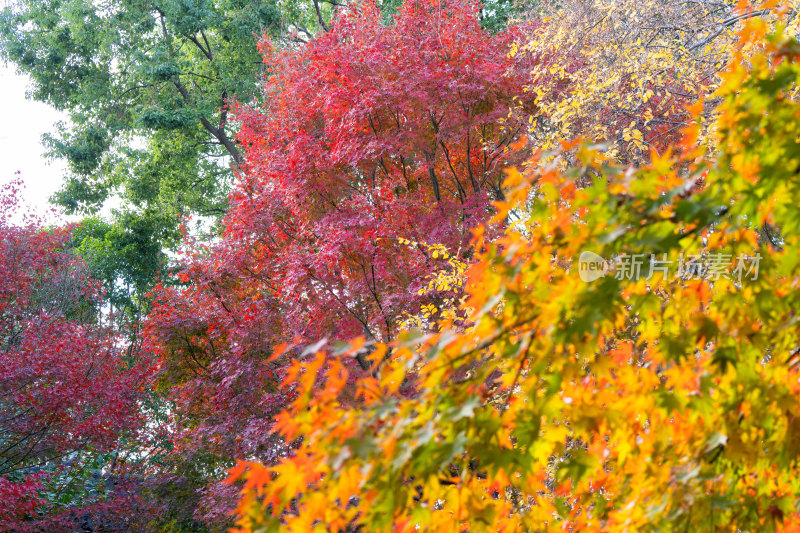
146, 0, 535, 517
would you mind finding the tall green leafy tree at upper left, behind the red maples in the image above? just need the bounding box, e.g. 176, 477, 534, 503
0, 0, 334, 318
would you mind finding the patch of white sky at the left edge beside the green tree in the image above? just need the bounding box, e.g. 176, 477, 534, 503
0, 62, 66, 219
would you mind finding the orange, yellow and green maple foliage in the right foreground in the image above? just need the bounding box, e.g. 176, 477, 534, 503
231, 3, 800, 531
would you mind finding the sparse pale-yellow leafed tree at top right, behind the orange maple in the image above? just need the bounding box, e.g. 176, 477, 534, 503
511, 0, 773, 162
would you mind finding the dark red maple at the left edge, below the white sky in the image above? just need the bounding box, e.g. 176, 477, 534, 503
0, 183, 150, 531
